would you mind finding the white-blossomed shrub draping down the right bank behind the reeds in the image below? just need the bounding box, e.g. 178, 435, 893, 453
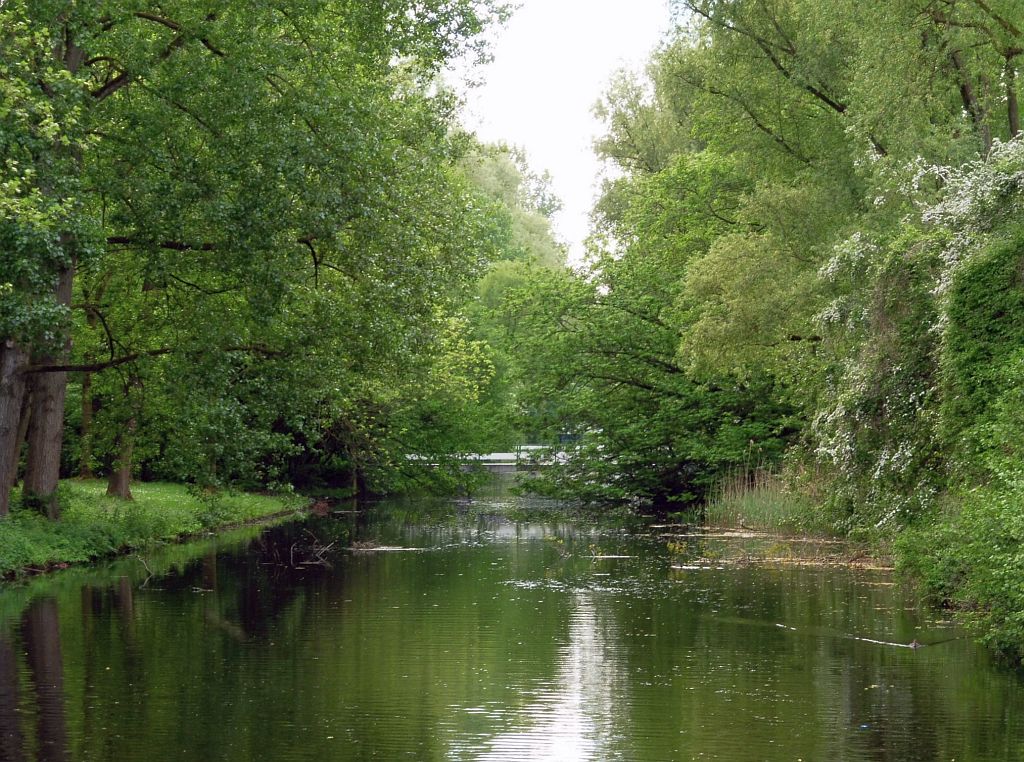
811, 139, 1024, 530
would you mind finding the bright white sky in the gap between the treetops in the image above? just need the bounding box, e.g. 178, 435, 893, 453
452, 0, 671, 262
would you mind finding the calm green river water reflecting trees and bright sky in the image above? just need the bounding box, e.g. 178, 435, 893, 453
0, 491, 1024, 762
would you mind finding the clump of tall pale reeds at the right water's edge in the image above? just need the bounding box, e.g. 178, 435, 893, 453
705, 469, 835, 535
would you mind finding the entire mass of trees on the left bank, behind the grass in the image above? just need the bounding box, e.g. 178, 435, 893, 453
0, 0, 573, 518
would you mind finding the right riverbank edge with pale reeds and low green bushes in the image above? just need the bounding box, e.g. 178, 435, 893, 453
705, 471, 1024, 665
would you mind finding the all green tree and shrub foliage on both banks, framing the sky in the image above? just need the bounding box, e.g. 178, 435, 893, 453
6, 0, 1024, 659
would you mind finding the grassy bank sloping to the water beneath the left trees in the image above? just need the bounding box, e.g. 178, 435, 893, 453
0, 480, 305, 578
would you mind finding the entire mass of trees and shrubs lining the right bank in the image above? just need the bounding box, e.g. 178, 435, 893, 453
508, 0, 1024, 659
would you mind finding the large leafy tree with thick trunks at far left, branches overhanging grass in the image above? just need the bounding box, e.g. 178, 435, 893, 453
0, 0, 501, 516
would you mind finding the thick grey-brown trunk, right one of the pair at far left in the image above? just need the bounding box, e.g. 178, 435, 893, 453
25, 264, 75, 520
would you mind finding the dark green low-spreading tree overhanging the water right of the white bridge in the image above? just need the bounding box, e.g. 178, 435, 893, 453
507, 249, 788, 507
